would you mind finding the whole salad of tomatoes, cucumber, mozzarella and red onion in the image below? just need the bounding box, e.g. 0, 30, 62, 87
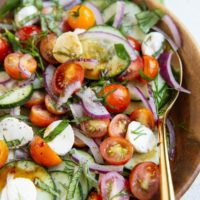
0, 0, 189, 200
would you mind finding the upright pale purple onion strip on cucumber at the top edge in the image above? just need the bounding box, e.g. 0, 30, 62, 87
113, 1, 125, 28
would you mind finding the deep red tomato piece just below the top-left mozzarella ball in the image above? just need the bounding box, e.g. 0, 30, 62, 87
16, 26, 41, 41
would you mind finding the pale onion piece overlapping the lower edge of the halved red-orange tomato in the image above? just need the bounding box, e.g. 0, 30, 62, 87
57, 81, 81, 107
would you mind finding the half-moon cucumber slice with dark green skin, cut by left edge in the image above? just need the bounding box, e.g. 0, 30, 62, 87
0, 85, 33, 109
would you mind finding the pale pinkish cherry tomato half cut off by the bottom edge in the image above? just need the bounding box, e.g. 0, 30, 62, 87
100, 172, 130, 200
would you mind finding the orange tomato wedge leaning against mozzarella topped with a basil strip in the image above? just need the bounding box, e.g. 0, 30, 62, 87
30, 136, 62, 167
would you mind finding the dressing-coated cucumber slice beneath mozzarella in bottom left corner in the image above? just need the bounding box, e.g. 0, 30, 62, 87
0, 160, 55, 200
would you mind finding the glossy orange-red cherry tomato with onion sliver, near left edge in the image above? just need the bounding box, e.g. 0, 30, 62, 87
4, 53, 37, 80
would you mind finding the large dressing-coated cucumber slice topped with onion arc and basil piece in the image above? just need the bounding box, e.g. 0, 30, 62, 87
79, 31, 131, 80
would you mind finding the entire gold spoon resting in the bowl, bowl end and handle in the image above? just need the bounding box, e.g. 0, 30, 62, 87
158, 52, 183, 200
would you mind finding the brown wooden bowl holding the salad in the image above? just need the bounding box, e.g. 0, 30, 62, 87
0, 0, 200, 199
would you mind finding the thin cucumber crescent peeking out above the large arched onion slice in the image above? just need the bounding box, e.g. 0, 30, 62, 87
88, 25, 126, 39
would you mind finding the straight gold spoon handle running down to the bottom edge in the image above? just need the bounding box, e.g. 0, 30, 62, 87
158, 120, 175, 200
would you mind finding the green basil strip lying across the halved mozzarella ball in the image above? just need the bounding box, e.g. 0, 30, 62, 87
44, 120, 69, 142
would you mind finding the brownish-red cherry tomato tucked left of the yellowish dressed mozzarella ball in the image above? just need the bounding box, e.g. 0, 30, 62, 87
40, 33, 58, 64
